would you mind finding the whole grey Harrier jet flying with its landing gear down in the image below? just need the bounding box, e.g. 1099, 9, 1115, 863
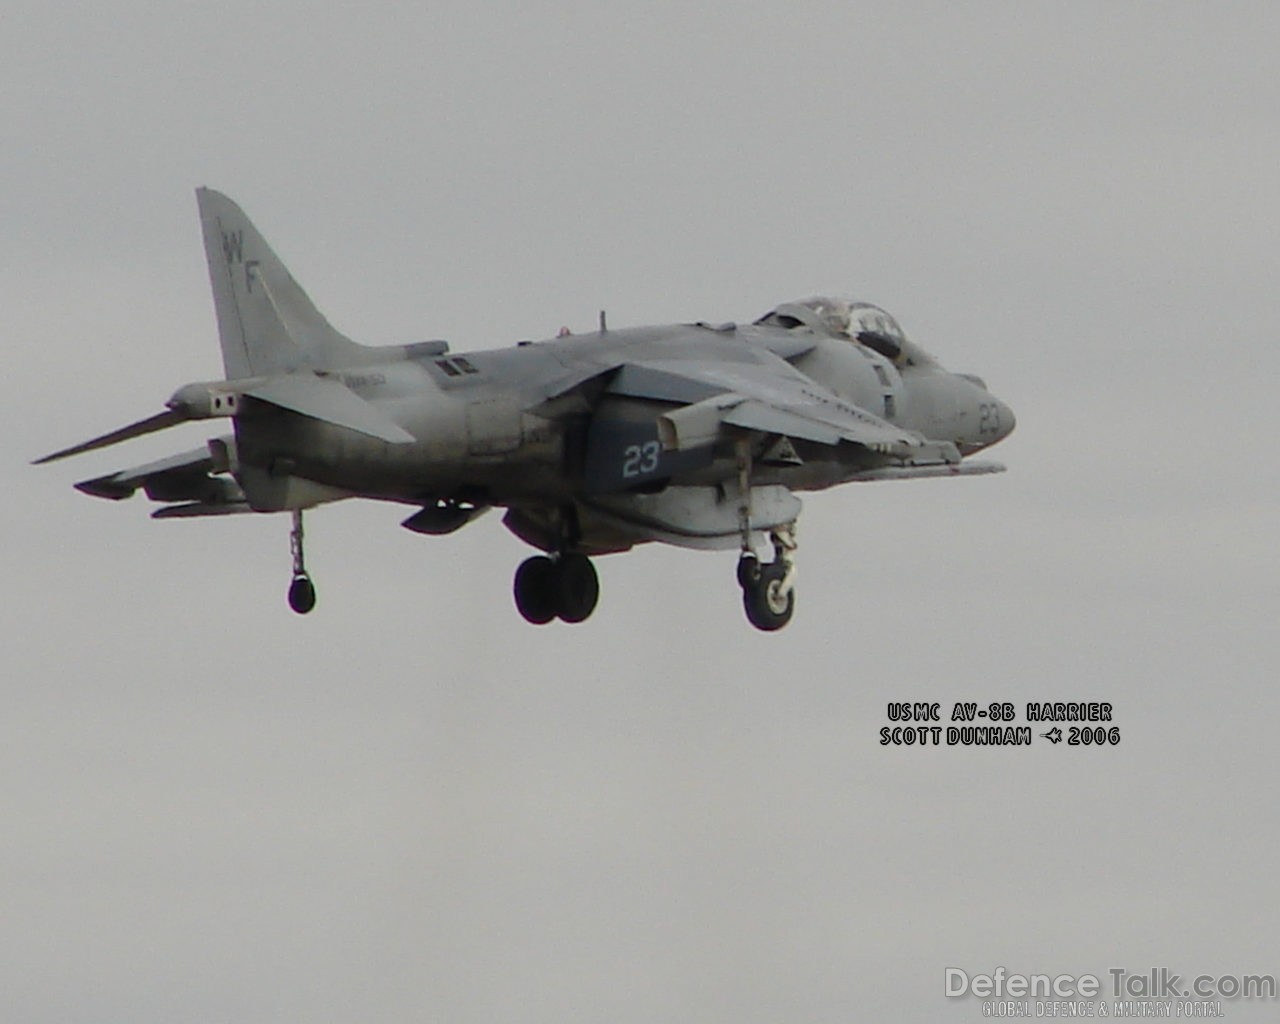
40, 188, 1014, 630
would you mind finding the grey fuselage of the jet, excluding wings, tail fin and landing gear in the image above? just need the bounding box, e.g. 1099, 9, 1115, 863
227, 325, 1014, 504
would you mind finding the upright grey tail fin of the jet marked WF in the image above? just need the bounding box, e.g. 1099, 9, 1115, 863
196, 188, 361, 380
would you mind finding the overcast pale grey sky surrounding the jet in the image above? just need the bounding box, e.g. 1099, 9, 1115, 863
0, 0, 1280, 1024
